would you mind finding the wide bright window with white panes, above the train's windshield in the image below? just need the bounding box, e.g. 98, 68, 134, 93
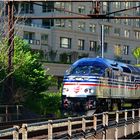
60, 37, 71, 49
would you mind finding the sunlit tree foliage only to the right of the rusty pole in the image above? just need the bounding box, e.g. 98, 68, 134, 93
14, 38, 51, 94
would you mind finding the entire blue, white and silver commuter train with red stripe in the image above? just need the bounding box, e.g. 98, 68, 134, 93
62, 57, 140, 112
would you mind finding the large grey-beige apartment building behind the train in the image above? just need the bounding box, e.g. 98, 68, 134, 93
4, 1, 140, 64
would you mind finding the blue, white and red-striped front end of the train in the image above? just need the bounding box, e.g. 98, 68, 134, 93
62, 59, 105, 113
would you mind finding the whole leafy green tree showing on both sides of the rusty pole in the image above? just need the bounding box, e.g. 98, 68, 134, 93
0, 37, 52, 102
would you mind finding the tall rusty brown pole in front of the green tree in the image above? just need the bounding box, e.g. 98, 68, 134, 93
5, 1, 14, 103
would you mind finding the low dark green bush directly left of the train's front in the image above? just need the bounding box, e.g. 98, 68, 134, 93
25, 92, 61, 117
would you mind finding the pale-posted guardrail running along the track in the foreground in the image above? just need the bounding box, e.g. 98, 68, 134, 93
0, 109, 140, 140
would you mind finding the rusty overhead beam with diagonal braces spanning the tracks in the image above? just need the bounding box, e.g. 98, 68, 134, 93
18, 0, 140, 19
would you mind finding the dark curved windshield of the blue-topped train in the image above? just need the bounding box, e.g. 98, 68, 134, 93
66, 65, 104, 75
